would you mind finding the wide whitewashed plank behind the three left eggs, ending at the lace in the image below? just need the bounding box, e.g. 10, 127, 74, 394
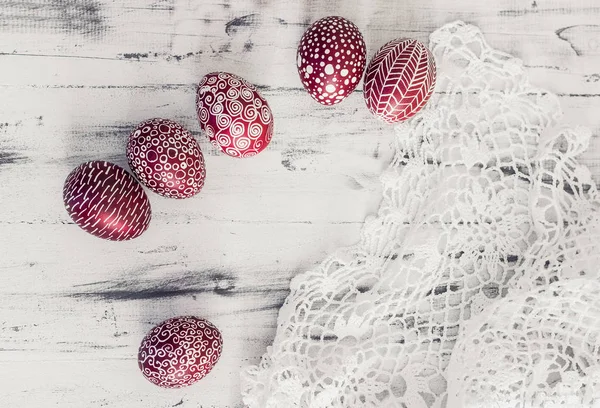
0, 88, 394, 228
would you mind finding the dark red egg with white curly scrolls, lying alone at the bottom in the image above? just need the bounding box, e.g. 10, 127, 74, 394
138, 316, 223, 388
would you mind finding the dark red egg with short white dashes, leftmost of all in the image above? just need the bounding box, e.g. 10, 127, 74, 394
63, 161, 151, 241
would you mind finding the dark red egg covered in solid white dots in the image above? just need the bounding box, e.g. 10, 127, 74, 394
297, 16, 367, 105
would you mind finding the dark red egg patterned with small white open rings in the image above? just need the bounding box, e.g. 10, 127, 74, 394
127, 119, 206, 198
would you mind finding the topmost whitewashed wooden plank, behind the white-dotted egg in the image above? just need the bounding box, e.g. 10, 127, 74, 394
0, 0, 600, 94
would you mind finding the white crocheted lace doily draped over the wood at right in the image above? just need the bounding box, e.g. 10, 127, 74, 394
242, 22, 600, 408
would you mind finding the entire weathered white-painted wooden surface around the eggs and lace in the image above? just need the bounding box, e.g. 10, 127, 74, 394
0, 0, 600, 408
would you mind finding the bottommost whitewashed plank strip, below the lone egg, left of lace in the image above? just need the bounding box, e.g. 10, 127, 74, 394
0, 358, 250, 408
